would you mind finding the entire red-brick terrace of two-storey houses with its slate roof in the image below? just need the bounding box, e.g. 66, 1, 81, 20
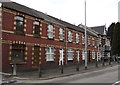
0, 2, 98, 71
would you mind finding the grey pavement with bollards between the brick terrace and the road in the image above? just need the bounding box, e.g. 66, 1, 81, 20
0, 62, 118, 83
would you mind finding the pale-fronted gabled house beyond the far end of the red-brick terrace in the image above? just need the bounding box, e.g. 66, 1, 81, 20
90, 25, 111, 60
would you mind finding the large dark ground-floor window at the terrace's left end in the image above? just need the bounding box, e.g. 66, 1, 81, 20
12, 44, 25, 62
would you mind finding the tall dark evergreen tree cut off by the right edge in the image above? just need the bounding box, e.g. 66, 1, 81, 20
112, 22, 120, 56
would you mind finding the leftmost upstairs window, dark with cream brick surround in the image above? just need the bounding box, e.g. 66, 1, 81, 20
16, 16, 24, 33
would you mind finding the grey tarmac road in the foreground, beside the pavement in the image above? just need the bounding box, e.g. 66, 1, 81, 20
18, 65, 120, 85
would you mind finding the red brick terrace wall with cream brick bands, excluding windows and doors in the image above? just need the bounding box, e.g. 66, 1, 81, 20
2, 9, 97, 70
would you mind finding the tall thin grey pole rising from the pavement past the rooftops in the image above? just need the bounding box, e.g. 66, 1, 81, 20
85, 0, 87, 70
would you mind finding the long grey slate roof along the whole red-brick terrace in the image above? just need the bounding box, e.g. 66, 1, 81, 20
2, 2, 96, 36
